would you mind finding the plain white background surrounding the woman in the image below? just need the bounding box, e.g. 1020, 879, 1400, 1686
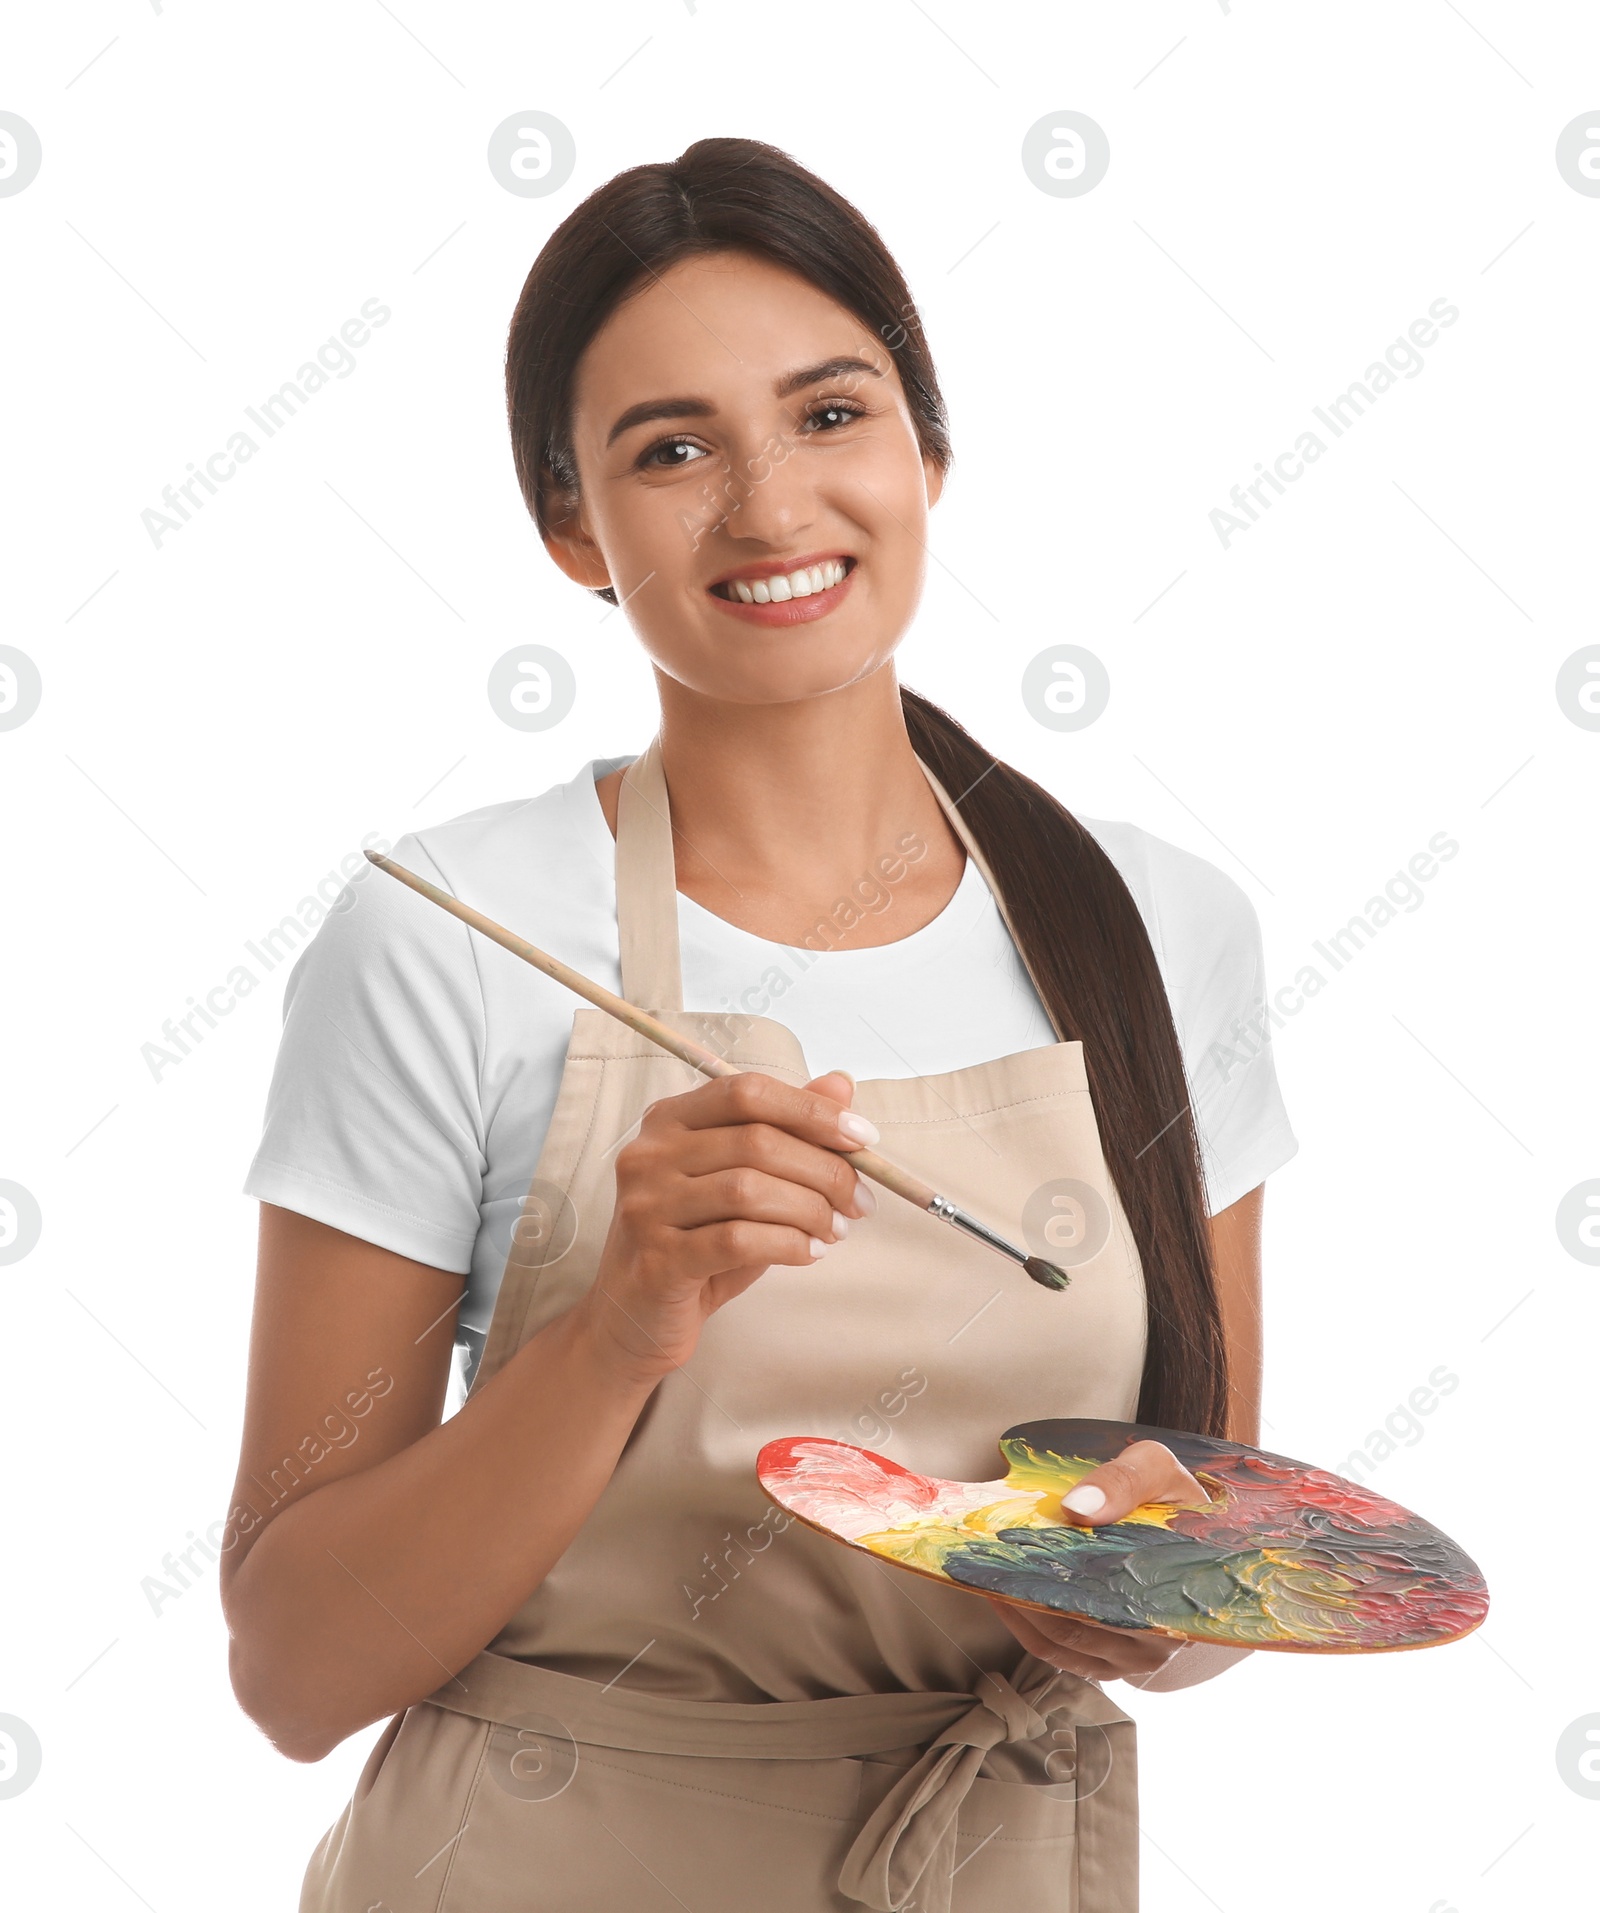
0, 0, 1600, 1913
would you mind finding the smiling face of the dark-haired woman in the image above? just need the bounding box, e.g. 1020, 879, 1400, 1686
551, 253, 940, 704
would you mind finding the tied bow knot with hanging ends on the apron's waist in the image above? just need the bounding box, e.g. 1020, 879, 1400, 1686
838, 1668, 1060, 1913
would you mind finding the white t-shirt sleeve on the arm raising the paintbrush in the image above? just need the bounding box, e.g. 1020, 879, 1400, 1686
245, 836, 486, 1274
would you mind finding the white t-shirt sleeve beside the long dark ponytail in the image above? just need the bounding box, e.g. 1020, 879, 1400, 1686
1146, 838, 1300, 1215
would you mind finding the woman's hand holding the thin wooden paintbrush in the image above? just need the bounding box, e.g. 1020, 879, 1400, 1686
574, 1069, 878, 1383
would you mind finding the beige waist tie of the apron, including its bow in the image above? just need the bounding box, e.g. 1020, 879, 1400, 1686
427, 1651, 1127, 1913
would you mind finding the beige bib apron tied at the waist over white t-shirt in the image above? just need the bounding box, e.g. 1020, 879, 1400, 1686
300, 740, 1144, 1913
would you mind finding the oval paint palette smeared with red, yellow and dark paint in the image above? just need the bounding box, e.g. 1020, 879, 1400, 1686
756, 1421, 1489, 1655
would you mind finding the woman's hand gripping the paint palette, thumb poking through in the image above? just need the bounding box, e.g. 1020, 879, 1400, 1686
986, 1440, 1210, 1685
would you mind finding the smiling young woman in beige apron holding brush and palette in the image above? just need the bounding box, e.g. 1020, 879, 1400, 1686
226, 140, 1294, 1913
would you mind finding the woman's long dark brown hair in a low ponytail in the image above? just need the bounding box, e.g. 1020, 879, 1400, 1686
505, 140, 1229, 1435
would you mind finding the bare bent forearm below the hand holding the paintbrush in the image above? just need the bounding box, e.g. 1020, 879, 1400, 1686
226, 1312, 651, 1760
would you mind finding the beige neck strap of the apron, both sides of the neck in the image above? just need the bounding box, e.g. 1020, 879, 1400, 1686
616, 733, 1037, 1033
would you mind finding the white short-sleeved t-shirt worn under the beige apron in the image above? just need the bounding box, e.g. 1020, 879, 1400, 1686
245, 756, 1298, 1352
